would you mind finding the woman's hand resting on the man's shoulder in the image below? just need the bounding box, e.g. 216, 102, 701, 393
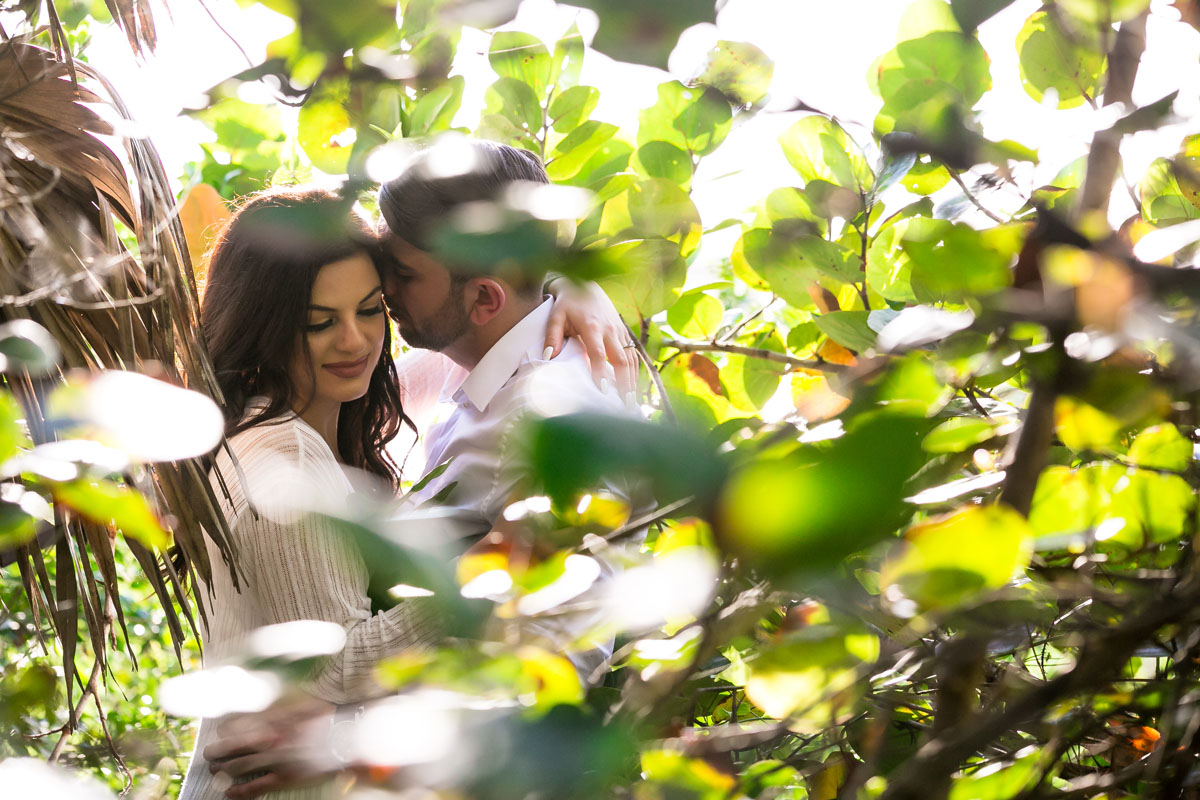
546, 278, 637, 405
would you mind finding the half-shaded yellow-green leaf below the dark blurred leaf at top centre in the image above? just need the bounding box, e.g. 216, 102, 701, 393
637, 80, 733, 157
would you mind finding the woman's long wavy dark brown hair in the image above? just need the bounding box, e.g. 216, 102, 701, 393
200, 188, 412, 488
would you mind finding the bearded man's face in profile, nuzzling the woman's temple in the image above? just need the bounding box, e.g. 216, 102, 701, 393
383, 235, 470, 350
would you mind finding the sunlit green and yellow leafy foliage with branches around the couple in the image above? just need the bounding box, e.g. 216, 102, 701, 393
7, 0, 1200, 798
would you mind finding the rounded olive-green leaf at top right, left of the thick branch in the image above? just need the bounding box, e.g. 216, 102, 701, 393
1016, 11, 1105, 108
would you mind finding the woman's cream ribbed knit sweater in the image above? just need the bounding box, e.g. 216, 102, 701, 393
180, 416, 439, 800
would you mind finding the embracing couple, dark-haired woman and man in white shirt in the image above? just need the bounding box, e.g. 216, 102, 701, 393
180, 142, 636, 800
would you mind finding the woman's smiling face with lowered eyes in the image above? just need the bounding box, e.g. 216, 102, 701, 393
290, 254, 388, 419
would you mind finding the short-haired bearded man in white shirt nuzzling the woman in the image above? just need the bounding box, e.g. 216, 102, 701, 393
379, 139, 636, 534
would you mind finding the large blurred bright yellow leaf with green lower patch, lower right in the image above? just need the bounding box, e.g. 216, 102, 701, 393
880, 505, 1033, 615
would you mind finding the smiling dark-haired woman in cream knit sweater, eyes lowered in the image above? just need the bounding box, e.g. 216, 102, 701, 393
180, 188, 628, 800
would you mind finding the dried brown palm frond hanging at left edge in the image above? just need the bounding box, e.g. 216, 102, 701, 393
0, 35, 234, 705
